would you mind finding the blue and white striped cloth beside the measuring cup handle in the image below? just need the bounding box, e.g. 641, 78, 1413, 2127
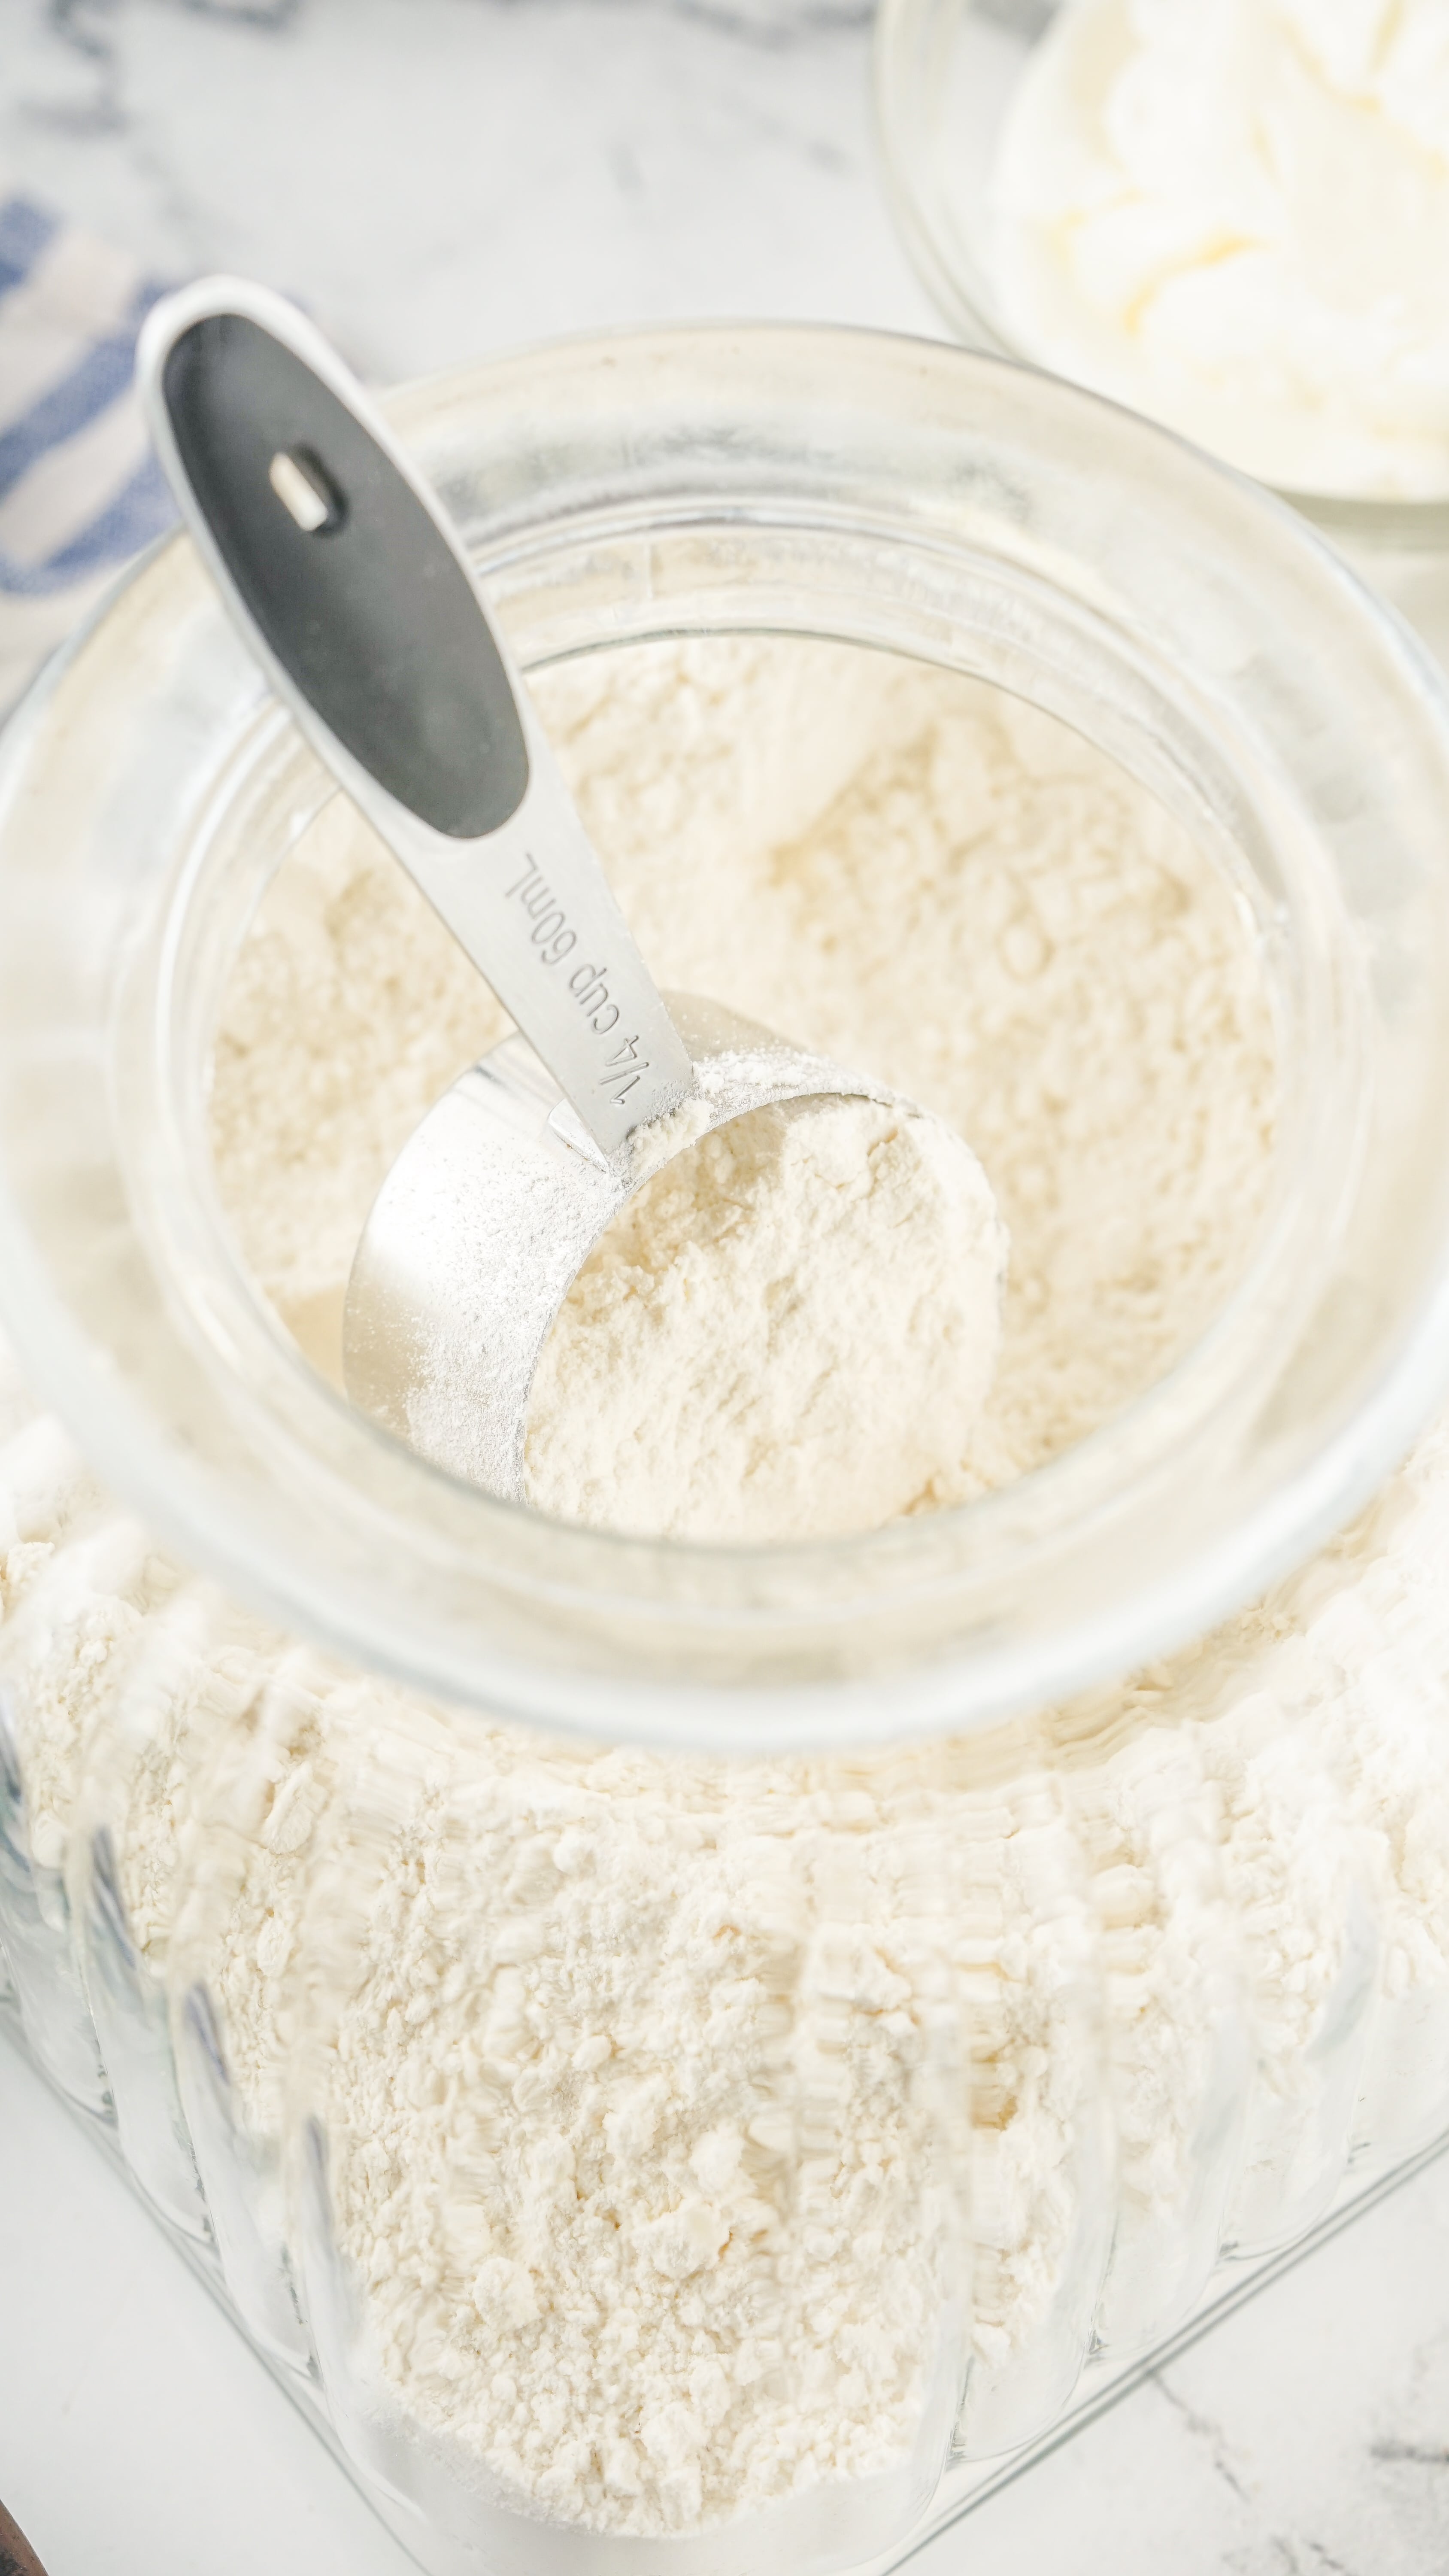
0, 193, 175, 716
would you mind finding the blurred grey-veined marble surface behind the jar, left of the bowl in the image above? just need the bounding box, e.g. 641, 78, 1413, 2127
0, 0, 937, 381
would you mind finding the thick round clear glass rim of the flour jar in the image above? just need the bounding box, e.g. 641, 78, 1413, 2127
0, 330, 1449, 1752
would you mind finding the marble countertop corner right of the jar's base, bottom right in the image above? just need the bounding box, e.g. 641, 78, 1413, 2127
947, 2159, 1449, 2576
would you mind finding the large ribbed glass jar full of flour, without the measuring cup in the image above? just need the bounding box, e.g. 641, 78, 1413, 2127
0, 330, 1449, 2571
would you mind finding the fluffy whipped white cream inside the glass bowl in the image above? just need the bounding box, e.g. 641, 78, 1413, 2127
994, 0, 1449, 500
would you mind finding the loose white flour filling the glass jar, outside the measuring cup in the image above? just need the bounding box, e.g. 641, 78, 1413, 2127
0, 641, 1449, 2535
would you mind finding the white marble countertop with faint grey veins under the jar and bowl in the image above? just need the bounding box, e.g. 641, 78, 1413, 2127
0, 0, 1449, 2576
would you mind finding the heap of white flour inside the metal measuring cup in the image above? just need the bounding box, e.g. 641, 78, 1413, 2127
525, 1097, 1006, 1543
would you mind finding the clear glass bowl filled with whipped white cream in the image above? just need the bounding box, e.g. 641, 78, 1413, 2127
875, 0, 1449, 659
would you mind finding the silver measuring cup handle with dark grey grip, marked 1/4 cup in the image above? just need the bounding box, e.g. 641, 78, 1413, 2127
136, 278, 692, 1151
